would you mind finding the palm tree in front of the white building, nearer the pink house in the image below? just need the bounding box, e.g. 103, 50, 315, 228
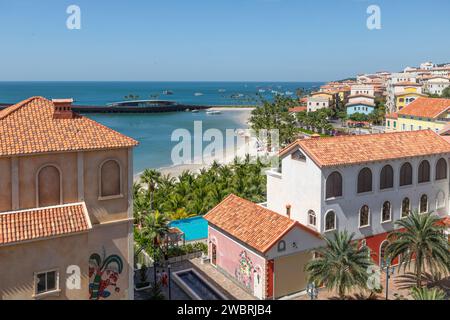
305, 231, 373, 299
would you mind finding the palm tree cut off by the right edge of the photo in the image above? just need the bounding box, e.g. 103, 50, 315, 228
386, 212, 450, 287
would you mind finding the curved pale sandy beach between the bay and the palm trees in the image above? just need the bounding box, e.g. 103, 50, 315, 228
134, 107, 256, 181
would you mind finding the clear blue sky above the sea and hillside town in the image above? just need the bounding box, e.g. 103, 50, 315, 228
0, 0, 450, 81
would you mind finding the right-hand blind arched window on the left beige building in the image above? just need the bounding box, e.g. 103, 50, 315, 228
100, 160, 122, 198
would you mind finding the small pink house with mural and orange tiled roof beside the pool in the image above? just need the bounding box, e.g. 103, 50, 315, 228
205, 195, 323, 299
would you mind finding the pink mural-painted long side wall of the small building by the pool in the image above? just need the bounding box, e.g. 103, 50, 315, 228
208, 226, 266, 298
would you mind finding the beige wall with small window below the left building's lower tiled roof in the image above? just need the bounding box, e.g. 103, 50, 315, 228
0, 233, 89, 300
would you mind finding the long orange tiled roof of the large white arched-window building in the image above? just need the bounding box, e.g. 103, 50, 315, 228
280, 130, 450, 167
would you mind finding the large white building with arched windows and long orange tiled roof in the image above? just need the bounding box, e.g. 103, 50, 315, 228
267, 130, 450, 261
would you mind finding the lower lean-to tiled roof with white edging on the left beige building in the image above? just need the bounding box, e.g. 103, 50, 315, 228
0, 203, 92, 245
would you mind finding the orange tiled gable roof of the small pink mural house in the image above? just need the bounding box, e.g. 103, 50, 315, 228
204, 194, 320, 253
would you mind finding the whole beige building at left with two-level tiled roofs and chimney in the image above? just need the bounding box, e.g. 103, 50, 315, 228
0, 97, 137, 300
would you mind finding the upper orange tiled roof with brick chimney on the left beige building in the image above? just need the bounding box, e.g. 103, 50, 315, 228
0, 97, 138, 156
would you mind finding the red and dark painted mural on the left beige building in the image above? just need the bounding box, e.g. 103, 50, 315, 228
89, 249, 123, 300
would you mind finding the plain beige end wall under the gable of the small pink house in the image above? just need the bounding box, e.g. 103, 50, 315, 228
275, 252, 312, 298
